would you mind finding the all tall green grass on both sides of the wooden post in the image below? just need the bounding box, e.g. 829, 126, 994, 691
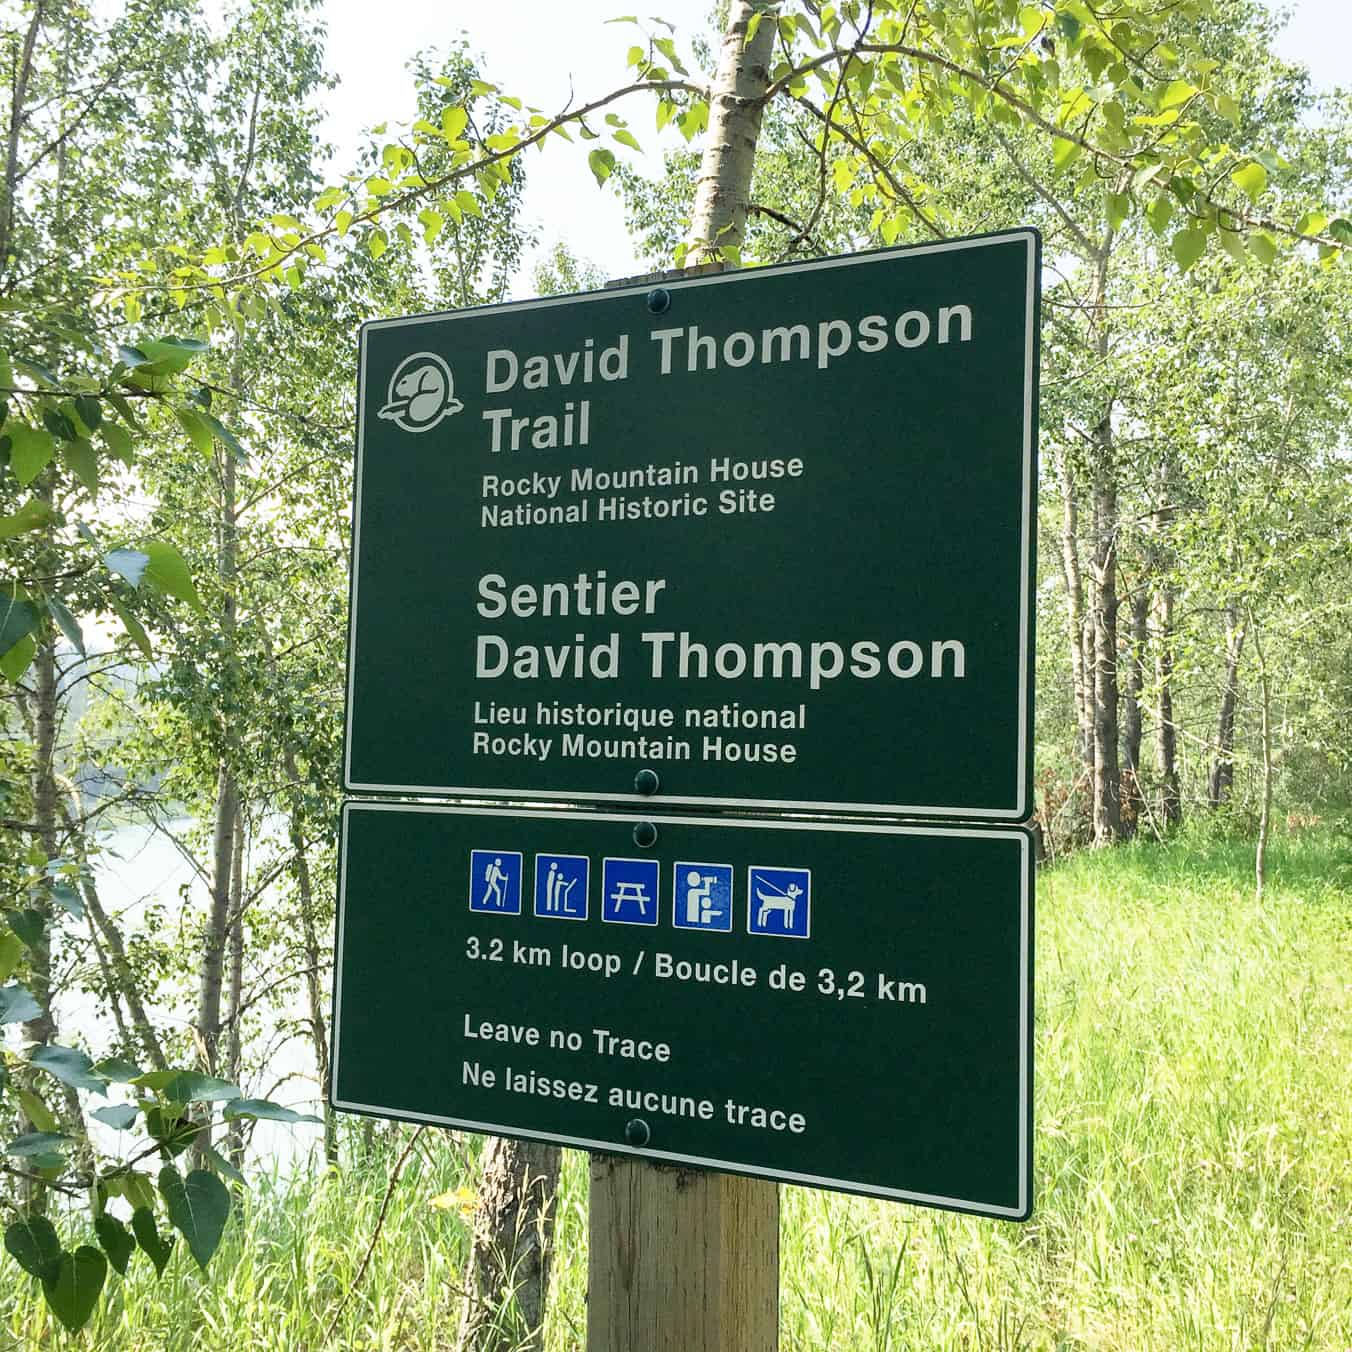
0, 825, 1352, 1352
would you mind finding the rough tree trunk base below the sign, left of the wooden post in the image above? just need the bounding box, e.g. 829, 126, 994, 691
460, 1137, 557, 1352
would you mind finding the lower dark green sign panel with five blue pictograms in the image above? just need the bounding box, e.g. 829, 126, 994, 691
333, 803, 1033, 1220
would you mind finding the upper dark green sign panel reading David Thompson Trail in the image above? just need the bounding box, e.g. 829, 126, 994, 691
345, 230, 1040, 821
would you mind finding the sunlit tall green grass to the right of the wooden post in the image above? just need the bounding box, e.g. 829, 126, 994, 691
781, 830, 1352, 1352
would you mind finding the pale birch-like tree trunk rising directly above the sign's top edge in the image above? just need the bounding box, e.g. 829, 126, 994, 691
687, 0, 777, 264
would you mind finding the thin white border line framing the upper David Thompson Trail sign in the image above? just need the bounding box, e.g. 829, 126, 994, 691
343, 227, 1041, 822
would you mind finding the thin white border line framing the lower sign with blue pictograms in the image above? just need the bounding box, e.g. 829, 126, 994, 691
329, 802, 1033, 1221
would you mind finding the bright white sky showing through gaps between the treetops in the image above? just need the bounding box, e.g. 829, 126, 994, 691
326, 0, 1352, 295
